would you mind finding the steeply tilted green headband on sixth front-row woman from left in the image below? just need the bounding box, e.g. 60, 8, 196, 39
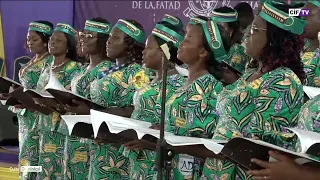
202, 20, 227, 62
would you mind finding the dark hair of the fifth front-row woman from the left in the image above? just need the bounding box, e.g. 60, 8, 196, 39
154, 21, 185, 65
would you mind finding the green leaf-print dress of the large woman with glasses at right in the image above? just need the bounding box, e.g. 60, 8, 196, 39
201, 68, 304, 180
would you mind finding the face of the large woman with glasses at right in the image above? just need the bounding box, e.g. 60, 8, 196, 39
244, 16, 267, 59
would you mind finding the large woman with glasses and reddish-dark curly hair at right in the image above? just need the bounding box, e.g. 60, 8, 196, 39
202, 1, 306, 180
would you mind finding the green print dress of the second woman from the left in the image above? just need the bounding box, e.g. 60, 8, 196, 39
37, 59, 80, 179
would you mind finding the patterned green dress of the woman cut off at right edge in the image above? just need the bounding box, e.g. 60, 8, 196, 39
301, 48, 320, 87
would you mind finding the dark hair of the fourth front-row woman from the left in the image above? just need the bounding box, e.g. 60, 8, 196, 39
124, 19, 145, 64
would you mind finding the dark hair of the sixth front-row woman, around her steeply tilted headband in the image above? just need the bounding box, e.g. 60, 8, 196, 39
192, 16, 231, 80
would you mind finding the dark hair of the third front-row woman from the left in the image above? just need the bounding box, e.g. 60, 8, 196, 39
90, 17, 110, 60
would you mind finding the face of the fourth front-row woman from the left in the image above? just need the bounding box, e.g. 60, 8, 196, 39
106, 27, 127, 59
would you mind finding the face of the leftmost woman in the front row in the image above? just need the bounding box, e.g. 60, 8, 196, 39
27, 31, 47, 54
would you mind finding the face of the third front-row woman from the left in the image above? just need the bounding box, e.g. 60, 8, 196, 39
81, 30, 98, 54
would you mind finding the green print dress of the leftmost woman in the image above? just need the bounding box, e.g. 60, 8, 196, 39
9, 56, 50, 179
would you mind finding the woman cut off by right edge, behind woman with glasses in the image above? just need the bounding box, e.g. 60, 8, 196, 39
301, 0, 320, 87
